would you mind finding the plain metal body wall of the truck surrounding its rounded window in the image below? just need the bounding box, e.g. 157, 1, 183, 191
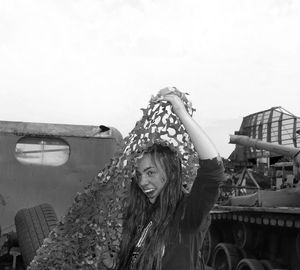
0, 121, 122, 233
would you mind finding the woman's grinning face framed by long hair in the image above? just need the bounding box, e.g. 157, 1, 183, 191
136, 154, 166, 203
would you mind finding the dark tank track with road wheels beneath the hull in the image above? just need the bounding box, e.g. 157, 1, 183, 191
205, 205, 300, 270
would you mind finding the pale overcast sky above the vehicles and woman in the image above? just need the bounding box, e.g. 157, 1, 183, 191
0, 0, 300, 157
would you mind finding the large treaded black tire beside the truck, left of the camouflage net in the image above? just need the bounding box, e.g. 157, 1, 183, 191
15, 204, 57, 266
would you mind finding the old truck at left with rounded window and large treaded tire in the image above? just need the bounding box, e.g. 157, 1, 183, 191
0, 121, 123, 269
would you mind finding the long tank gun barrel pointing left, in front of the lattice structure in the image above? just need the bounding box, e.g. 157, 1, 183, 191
229, 135, 300, 158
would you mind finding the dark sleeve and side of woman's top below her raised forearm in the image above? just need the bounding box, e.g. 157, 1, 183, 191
162, 158, 225, 270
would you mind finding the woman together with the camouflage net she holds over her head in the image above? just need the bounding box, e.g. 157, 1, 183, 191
30, 88, 224, 270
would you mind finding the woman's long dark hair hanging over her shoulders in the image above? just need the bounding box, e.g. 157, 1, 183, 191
118, 144, 183, 270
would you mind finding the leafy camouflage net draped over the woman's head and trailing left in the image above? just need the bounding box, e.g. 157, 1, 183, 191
29, 89, 198, 270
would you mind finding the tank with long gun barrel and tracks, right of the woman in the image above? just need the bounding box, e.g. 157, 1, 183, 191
203, 135, 300, 270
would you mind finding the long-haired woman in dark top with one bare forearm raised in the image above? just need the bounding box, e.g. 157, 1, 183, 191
106, 88, 224, 270
